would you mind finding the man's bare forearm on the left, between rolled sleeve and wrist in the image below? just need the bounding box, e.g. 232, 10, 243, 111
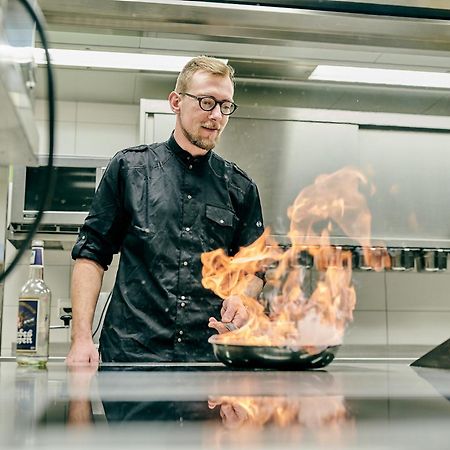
71, 258, 104, 342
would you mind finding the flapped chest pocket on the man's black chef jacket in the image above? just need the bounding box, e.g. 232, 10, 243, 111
205, 205, 239, 248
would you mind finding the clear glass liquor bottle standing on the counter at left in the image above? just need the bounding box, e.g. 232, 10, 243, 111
16, 241, 51, 367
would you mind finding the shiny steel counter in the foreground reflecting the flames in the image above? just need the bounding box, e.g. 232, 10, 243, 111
0, 359, 450, 449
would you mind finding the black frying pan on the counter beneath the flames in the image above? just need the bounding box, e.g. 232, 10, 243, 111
209, 336, 339, 370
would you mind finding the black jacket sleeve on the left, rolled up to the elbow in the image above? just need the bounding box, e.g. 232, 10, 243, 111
72, 152, 129, 270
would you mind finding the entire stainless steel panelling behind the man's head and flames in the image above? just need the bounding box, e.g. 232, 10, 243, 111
145, 100, 450, 248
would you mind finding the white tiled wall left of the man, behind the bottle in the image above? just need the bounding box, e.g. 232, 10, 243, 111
0, 101, 139, 356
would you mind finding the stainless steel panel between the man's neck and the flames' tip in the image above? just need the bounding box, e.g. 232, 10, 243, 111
217, 118, 358, 235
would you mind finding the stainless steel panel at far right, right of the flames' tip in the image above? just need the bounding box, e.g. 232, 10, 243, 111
358, 129, 450, 248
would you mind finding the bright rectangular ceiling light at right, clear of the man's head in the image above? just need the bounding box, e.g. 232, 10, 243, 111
308, 65, 450, 89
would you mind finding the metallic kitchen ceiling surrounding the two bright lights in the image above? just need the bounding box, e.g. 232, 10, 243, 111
37, 0, 450, 115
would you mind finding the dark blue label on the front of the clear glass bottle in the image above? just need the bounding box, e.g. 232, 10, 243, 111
16, 298, 39, 352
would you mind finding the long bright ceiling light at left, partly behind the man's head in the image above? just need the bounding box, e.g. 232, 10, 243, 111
34, 48, 228, 72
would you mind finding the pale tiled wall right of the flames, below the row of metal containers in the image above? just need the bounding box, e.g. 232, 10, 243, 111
344, 271, 450, 346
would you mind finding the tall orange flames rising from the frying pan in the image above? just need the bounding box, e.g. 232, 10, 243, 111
201, 168, 390, 353
